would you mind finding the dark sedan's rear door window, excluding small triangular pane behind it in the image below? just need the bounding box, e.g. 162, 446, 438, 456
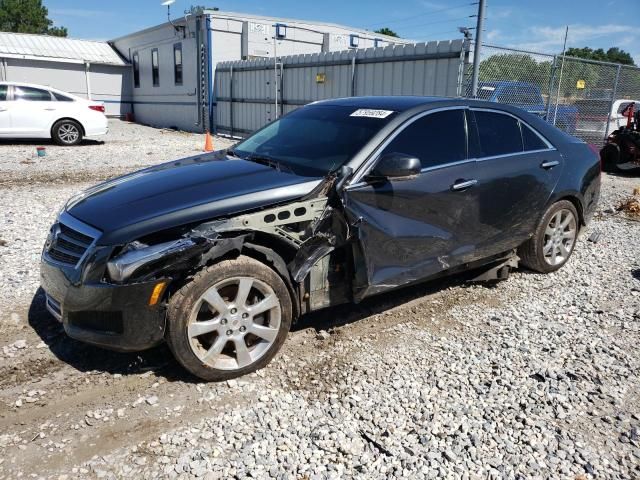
474, 111, 523, 157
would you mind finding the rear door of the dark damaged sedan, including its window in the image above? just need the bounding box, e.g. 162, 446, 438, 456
470, 109, 563, 257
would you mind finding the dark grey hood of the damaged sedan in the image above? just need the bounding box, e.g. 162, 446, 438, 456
66, 152, 320, 245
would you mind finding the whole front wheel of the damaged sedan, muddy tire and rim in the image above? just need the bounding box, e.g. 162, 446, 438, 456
166, 256, 292, 381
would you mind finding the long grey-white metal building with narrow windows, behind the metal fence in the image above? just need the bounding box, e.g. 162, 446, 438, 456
110, 9, 412, 131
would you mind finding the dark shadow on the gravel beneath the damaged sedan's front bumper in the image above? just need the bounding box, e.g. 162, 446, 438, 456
29, 288, 199, 383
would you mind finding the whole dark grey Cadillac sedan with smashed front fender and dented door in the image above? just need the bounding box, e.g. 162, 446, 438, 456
41, 97, 600, 380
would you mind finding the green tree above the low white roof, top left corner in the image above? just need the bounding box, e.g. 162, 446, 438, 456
0, 0, 67, 37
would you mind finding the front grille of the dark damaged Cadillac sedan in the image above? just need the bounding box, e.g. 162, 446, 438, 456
45, 212, 100, 266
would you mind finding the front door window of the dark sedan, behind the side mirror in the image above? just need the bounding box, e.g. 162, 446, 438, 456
383, 109, 467, 168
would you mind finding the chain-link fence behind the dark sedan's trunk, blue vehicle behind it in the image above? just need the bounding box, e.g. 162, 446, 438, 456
466, 45, 640, 144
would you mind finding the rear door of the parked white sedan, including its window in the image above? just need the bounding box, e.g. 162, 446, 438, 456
11, 85, 57, 137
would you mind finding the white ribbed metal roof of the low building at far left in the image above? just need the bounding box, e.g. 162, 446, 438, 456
0, 32, 127, 65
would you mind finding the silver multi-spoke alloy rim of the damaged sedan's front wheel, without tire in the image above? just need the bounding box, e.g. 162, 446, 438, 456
187, 277, 282, 370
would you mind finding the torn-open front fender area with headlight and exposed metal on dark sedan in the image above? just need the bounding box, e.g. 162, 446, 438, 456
106, 175, 353, 313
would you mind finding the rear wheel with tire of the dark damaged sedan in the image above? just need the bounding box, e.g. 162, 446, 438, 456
518, 200, 580, 273
